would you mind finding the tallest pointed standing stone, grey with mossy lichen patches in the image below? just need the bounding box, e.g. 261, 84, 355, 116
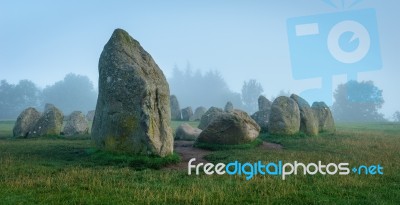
92, 29, 174, 156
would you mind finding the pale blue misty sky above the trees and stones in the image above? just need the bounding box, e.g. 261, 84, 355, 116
0, 0, 400, 116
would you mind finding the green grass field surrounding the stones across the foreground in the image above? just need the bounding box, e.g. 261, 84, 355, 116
0, 122, 400, 204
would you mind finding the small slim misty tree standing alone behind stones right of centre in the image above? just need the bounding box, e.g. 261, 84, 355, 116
242, 79, 264, 113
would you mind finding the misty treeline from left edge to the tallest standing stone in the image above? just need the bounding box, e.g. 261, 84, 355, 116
0, 73, 97, 119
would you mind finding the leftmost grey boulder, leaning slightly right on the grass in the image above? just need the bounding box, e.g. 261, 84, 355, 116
13, 107, 40, 137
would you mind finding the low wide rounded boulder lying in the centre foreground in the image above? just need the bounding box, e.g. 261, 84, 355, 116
197, 110, 260, 145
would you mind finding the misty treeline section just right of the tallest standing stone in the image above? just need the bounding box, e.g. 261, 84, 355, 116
168, 66, 263, 113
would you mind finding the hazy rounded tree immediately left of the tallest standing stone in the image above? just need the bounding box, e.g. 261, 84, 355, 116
43, 73, 97, 114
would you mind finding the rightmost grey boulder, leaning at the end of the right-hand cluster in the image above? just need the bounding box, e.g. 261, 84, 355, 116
311, 102, 336, 133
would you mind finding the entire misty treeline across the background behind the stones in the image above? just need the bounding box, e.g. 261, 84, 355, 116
0, 66, 394, 122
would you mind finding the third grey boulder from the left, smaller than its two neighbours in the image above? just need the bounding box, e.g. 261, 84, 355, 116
63, 111, 89, 136
